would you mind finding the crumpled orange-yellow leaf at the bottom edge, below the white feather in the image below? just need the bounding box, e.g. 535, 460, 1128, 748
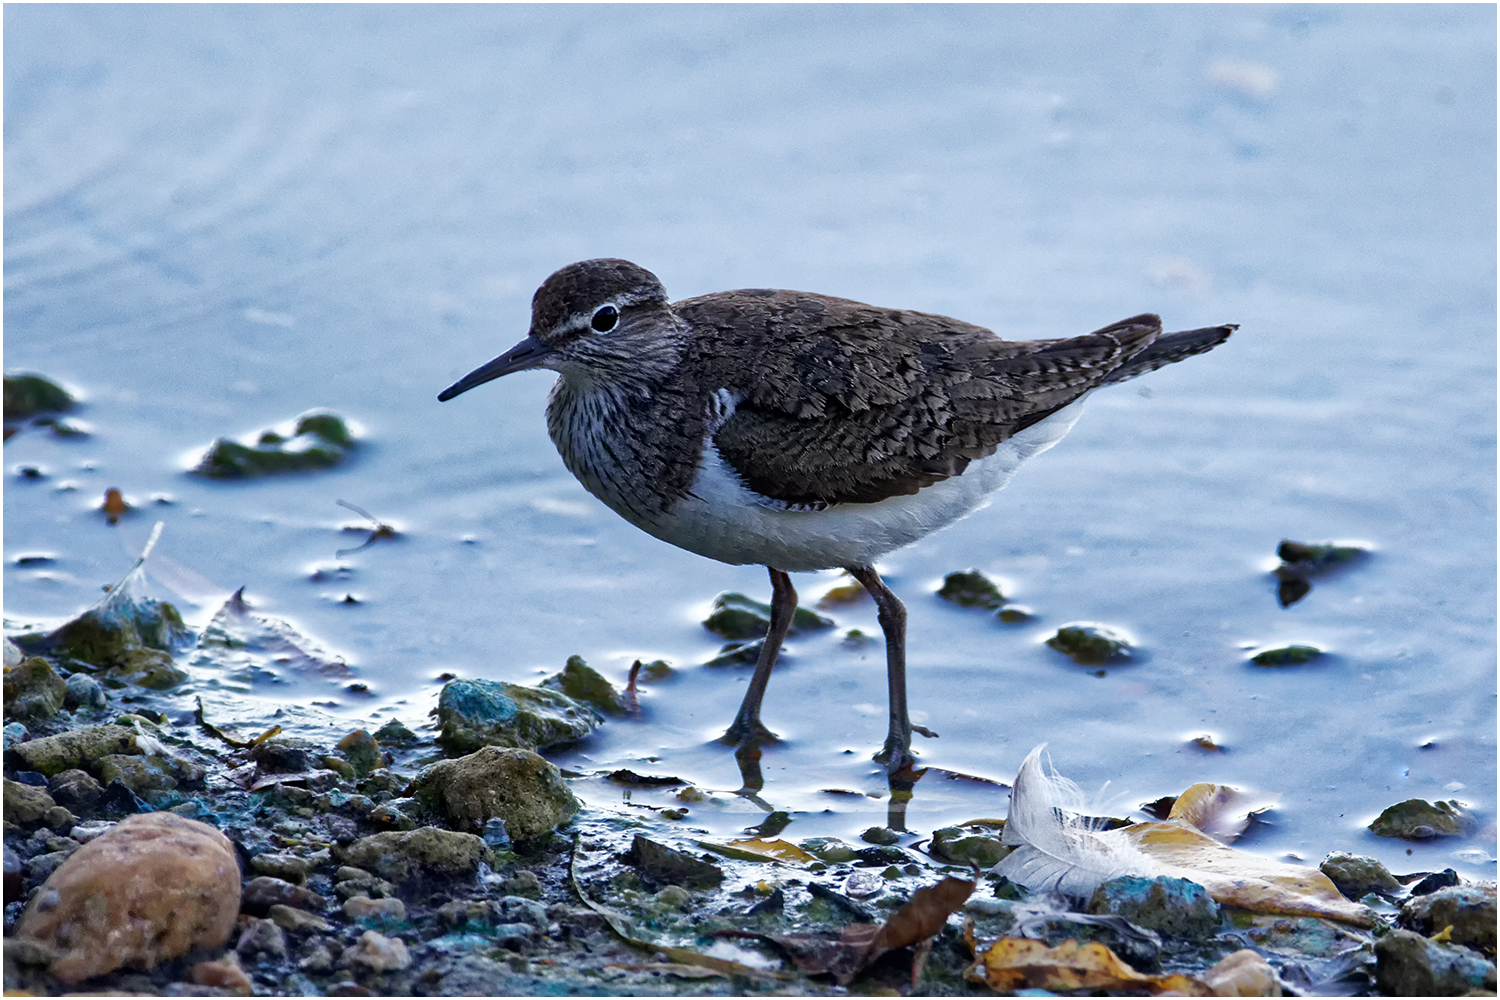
968, 937, 1214, 997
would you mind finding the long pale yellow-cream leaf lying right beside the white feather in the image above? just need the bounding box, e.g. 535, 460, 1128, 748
1121, 820, 1376, 927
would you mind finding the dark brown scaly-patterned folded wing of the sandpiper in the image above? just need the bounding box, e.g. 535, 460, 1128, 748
674, 289, 1161, 504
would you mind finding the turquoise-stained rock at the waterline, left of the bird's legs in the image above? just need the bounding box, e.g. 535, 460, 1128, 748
438, 679, 603, 753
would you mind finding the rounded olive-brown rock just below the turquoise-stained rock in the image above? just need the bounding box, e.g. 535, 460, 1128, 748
414, 747, 579, 850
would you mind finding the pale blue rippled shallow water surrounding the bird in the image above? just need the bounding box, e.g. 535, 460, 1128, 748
5, 6, 1496, 877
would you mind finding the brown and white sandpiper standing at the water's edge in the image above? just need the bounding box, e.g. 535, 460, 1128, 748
438, 259, 1236, 774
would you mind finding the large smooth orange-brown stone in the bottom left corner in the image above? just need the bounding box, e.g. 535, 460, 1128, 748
17, 813, 240, 984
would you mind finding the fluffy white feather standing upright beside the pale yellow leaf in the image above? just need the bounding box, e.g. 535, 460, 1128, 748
992, 744, 1163, 895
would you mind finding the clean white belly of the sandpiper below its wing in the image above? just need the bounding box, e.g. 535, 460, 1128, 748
627, 399, 1083, 571
